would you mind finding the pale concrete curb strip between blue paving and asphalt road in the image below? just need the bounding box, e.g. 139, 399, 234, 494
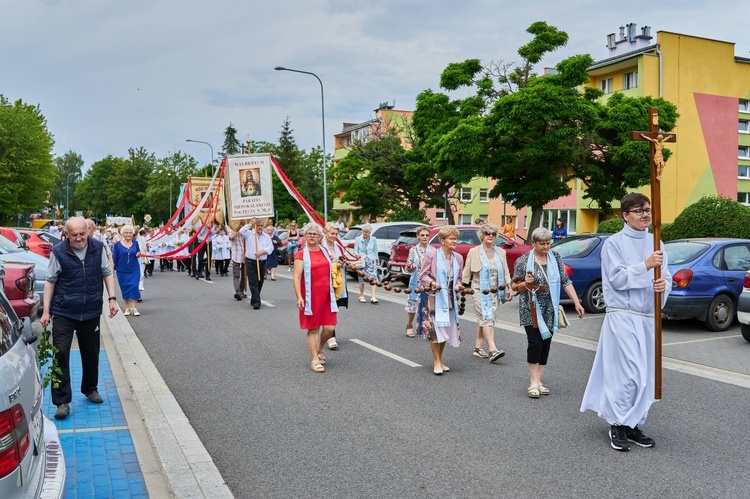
102, 313, 234, 499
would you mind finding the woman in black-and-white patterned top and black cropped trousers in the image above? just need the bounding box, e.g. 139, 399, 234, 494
512, 227, 584, 398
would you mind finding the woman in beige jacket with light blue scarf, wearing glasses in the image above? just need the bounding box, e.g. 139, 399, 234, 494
463, 222, 513, 362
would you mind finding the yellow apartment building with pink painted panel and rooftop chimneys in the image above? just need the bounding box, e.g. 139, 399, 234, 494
576, 24, 750, 232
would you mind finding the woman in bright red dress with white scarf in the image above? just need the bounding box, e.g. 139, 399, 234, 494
294, 223, 338, 373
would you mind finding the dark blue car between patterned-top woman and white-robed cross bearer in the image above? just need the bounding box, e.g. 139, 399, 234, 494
552, 234, 610, 314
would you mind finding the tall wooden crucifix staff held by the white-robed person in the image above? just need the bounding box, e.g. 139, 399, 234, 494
630, 107, 677, 400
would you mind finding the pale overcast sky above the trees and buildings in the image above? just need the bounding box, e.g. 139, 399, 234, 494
0, 0, 750, 167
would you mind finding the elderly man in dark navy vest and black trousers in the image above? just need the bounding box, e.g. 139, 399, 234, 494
40, 217, 119, 419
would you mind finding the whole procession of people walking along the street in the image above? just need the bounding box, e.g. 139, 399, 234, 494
41, 193, 671, 451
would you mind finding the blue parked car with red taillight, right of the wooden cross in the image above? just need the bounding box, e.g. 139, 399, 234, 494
662, 238, 750, 331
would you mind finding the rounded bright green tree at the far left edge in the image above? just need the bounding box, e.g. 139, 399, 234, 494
0, 94, 57, 223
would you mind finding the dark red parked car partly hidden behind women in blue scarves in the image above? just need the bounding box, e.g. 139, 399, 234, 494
388, 225, 532, 284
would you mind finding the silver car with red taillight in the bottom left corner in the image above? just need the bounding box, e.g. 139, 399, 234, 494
0, 291, 65, 499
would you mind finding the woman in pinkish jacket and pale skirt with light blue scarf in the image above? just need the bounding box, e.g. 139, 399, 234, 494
419, 225, 464, 375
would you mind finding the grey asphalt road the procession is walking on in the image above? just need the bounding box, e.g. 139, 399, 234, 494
130, 272, 750, 498
